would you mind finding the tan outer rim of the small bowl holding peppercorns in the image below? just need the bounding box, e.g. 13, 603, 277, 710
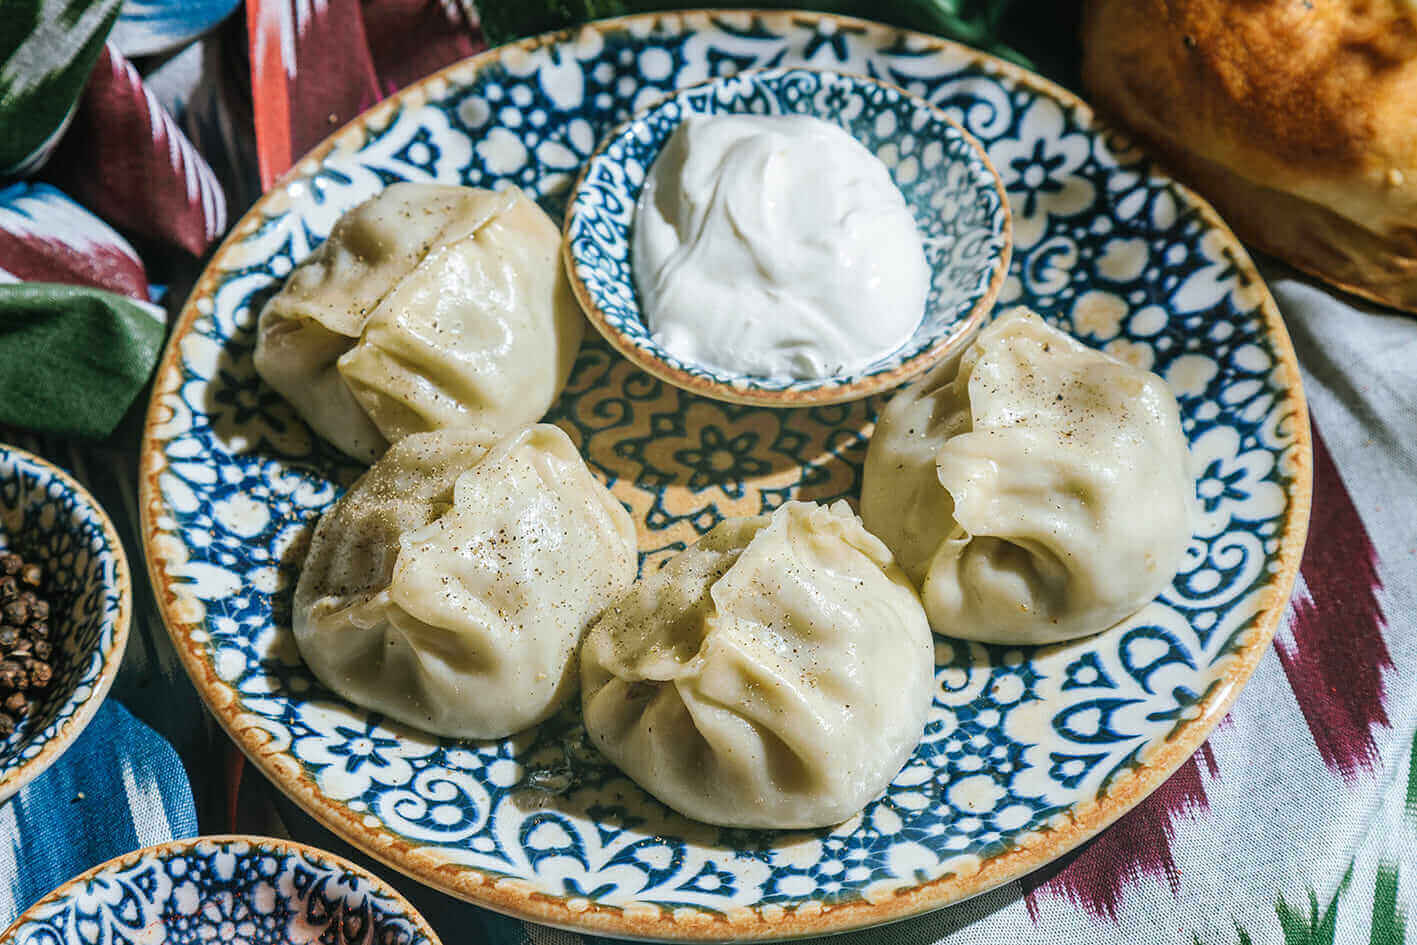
0, 443, 133, 803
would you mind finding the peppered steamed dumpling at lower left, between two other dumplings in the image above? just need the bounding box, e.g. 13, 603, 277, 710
295, 425, 636, 738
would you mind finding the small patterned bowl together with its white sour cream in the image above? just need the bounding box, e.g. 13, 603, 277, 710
564, 69, 1010, 407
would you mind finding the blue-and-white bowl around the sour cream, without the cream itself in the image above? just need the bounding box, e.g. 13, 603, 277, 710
564, 68, 1012, 407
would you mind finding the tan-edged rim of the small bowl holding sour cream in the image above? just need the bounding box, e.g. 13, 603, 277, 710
561, 65, 1013, 408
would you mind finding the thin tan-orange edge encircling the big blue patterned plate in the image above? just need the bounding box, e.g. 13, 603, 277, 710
140, 10, 1312, 941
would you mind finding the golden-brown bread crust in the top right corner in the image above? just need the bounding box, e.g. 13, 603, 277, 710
1083, 0, 1417, 310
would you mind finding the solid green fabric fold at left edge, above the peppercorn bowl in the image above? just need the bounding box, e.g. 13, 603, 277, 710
0, 282, 164, 438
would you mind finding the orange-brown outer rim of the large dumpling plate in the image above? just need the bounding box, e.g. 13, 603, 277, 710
139, 7, 1312, 941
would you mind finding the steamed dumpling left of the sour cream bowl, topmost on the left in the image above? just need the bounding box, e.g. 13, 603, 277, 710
255, 183, 585, 460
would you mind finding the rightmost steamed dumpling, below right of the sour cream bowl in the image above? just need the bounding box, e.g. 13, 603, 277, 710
862, 309, 1195, 643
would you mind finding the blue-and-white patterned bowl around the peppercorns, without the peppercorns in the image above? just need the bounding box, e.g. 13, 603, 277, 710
0, 445, 133, 800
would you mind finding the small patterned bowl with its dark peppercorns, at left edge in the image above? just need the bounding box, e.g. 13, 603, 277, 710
0, 443, 133, 800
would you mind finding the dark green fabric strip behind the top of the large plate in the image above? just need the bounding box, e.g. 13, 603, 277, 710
478, 0, 1081, 88
